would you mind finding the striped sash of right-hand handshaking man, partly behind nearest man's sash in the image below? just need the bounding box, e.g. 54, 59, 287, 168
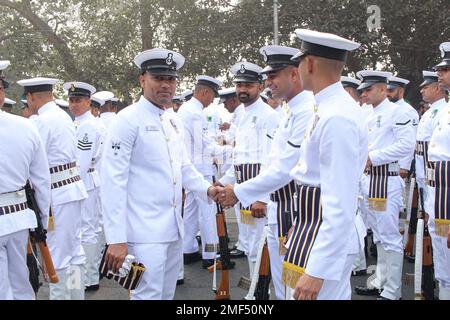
270, 181, 298, 256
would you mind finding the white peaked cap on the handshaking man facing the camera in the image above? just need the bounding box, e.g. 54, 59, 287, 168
134, 48, 186, 77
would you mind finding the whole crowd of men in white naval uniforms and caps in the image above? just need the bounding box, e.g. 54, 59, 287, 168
0, 29, 450, 300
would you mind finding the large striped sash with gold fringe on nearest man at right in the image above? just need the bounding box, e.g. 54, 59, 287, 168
282, 186, 322, 288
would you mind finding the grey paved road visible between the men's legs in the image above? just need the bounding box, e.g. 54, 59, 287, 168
38, 211, 426, 300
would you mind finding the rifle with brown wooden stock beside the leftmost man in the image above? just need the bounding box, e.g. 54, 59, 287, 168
25, 182, 59, 283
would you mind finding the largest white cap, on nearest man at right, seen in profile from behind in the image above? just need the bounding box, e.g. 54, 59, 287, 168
292, 29, 360, 62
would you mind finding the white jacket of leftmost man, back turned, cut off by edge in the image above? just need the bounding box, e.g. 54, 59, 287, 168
0, 111, 50, 237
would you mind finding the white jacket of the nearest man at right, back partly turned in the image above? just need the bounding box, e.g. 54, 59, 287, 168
291, 82, 368, 281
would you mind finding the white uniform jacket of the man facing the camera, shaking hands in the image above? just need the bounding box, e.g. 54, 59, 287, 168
100, 96, 210, 244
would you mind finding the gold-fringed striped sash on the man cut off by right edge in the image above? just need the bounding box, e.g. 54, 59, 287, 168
434, 161, 450, 237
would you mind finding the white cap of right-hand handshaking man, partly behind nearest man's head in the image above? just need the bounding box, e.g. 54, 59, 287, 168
259, 45, 300, 74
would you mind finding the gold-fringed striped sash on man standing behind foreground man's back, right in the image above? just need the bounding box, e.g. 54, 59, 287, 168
369, 163, 399, 211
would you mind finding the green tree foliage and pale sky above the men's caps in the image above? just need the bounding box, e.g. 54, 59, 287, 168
0, 0, 450, 107
